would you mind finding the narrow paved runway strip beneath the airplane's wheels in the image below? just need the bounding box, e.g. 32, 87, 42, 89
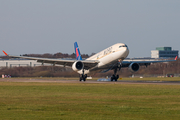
0, 78, 180, 85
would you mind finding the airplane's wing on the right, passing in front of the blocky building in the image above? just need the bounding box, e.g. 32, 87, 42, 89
122, 57, 177, 67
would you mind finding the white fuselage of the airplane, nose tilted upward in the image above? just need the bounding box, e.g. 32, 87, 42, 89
78, 43, 129, 74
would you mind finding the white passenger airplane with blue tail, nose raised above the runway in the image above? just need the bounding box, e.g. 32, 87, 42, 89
3, 42, 177, 81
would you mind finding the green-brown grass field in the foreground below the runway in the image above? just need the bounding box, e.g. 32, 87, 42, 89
0, 82, 180, 120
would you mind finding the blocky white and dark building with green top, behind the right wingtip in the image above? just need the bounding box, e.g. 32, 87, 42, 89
151, 47, 179, 58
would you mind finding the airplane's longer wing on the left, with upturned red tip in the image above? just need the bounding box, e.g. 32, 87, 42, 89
3, 51, 99, 69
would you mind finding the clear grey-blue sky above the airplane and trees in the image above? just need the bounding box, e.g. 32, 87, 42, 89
0, 0, 180, 57
